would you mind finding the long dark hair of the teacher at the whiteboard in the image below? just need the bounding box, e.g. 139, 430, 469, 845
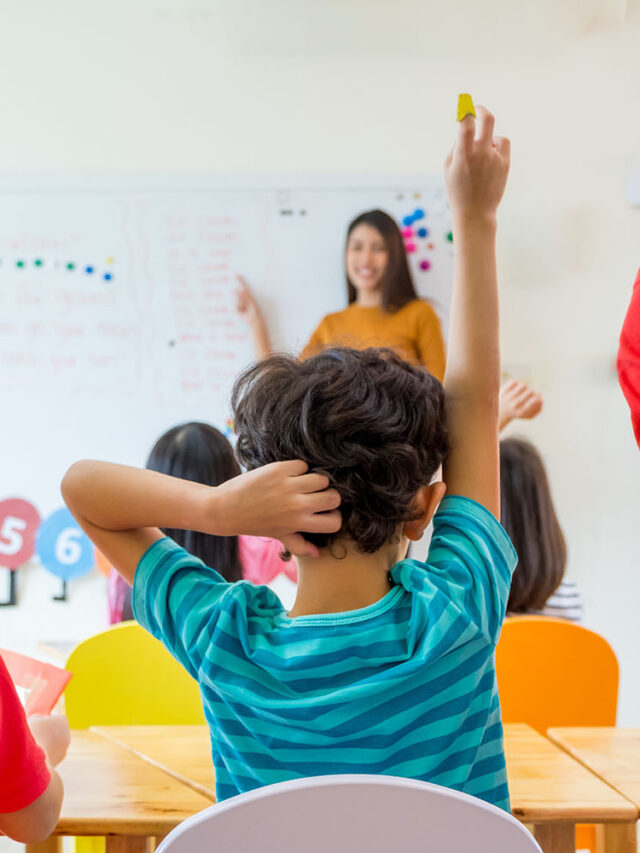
345, 210, 418, 313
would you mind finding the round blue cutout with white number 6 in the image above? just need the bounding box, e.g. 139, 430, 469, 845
36, 508, 95, 582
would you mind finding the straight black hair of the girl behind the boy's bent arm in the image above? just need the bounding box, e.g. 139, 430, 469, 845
147, 421, 242, 581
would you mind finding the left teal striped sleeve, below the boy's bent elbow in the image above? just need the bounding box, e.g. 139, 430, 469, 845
133, 536, 235, 678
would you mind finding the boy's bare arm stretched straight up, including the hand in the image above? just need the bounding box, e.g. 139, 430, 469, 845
444, 107, 510, 518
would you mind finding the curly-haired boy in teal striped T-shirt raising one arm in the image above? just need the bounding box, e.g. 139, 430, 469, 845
62, 107, 516, 809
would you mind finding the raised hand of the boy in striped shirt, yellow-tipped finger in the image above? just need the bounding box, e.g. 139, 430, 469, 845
444, 107, 511, 219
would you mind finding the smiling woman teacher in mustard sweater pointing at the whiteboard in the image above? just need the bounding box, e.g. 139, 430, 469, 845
238, 210, 445, 381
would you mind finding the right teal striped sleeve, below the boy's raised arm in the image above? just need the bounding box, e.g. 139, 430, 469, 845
425, 495, 518, 643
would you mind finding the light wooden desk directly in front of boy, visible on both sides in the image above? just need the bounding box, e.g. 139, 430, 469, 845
94, 725, 638, 853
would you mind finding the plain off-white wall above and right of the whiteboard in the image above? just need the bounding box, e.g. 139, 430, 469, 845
0, 0, 640, 725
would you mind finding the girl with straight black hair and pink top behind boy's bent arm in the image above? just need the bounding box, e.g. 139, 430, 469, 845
109, 421, 290, 624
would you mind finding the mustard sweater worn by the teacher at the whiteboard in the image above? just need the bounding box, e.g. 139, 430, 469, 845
301, 299, 445, 381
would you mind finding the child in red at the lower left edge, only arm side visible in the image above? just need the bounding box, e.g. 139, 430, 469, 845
0, 658, 70, 844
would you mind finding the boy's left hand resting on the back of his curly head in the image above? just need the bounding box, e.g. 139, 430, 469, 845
212, 460, 342, 556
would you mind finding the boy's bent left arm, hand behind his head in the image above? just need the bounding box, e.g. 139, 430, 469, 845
62, 460, 342, 584
